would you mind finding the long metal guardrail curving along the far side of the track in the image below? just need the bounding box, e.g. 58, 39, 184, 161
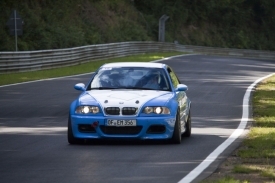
0, 41, 275, 74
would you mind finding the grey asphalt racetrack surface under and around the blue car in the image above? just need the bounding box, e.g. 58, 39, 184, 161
0, 55, 275, 183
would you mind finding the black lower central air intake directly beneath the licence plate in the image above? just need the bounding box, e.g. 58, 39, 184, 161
100, 125, 142, 135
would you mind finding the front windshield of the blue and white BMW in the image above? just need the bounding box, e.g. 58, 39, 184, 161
88, 67, 171, 91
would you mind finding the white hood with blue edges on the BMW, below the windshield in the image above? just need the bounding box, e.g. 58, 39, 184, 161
79, 90, 173, 108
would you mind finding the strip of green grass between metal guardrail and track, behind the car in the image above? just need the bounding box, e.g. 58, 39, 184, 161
0, 52, 186, 85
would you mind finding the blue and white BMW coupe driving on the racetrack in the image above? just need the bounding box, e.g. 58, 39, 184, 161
67, 62, 191, 144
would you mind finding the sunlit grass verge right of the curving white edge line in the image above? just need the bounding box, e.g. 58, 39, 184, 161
202, 75, 275, 183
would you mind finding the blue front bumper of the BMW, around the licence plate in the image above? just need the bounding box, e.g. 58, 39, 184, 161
71, 115, 176, 140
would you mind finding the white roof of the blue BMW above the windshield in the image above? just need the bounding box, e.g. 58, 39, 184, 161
101, 62, 166, 68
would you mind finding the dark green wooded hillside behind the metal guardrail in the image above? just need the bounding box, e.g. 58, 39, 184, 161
0, 0, 275, 51
